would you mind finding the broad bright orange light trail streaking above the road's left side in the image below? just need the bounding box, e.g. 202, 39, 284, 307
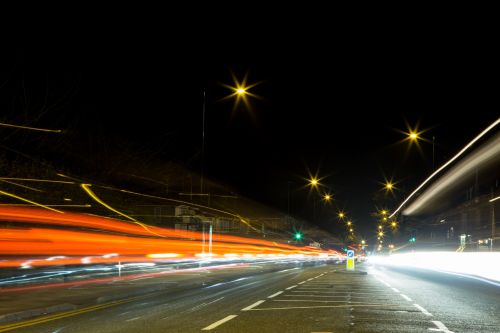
0, 207, 337, 267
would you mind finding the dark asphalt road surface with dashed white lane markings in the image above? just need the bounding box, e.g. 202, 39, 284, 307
0, 263, 500, 333
